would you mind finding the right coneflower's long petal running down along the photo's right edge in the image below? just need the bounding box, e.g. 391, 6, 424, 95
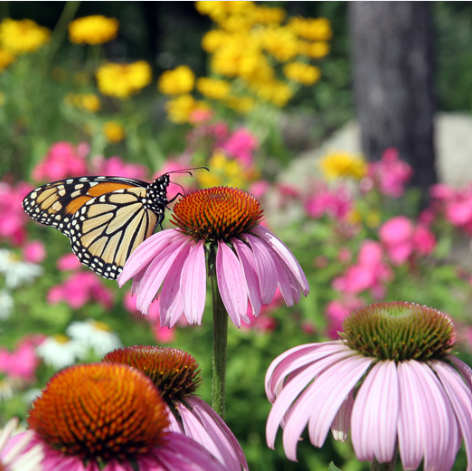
429, 360, 472, 471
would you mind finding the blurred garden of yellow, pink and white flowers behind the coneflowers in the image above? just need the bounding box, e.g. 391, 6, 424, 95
0, 2, 472, 471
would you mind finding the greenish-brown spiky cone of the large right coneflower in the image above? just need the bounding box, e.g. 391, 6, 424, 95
341, 302, 455, 361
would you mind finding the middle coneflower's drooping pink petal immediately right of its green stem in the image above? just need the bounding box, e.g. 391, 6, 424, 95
216, 241, 248, 327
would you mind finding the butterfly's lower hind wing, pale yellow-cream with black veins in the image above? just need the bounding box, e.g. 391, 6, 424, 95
69, 188, 160, 280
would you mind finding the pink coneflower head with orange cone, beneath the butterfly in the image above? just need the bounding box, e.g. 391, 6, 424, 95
118, 187, 309, 327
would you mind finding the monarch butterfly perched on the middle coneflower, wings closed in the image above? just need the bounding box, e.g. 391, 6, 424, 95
23, 169, 196, 280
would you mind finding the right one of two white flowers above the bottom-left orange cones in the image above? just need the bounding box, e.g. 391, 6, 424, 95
66, 319, 122, 357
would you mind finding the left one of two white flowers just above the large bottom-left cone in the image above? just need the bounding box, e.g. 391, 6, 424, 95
36, 335, 86, 370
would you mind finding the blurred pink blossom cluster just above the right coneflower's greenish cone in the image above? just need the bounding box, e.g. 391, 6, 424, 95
333, 240, 392, 299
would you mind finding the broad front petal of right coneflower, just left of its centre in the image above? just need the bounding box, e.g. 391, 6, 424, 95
352, 361, 399, 463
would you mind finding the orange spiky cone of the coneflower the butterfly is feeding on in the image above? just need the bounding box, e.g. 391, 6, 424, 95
171, 186, 263, 243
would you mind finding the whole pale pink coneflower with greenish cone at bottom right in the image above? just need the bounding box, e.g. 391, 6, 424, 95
266, 302, 472, 471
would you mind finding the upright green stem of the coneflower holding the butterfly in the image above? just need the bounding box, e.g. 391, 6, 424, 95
208, 247, 228, 420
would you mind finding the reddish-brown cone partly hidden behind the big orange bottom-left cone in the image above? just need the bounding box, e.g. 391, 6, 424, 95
102, 346, 201, 404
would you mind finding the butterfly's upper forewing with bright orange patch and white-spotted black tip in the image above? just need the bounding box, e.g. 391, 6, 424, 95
23, 176, 147, 236
